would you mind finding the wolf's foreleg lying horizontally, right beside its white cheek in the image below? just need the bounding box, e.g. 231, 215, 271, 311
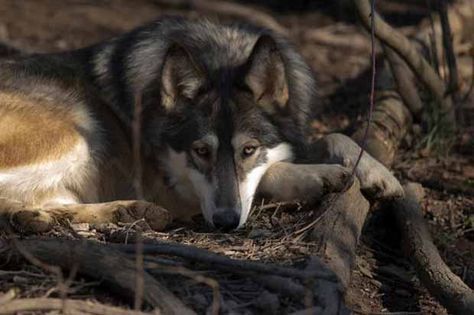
258, 162, 352, 203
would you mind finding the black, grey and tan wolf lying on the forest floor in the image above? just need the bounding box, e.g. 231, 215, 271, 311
0, 17, 402, 232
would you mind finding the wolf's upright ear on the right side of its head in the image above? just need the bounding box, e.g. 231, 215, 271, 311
245, 35, 289, 112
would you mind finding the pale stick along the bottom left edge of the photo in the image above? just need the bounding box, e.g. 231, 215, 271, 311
0, 298, 147, 315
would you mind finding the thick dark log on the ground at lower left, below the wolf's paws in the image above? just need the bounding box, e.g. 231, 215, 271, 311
0, 239, 195, 315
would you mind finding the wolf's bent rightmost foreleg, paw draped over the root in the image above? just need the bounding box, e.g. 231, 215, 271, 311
309, 133, 403, 198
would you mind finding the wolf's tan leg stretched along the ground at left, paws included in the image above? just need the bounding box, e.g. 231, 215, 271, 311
0, 198, 171, 233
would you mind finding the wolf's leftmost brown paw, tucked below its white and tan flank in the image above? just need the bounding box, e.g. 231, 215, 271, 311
10, 209, 54, 234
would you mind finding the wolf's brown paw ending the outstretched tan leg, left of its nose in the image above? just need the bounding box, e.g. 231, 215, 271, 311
114, 200, 172, 231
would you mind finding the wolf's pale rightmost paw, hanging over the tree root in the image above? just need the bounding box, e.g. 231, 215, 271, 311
344, 152, 403, 199
